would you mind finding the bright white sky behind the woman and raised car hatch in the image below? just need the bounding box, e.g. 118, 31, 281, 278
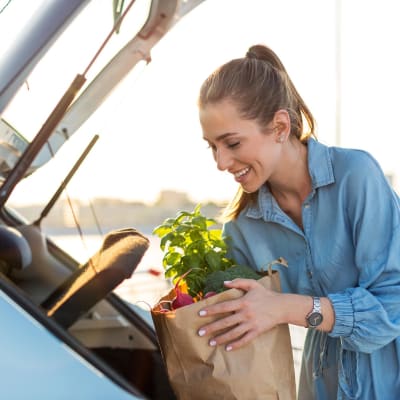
0, 0, 400, 203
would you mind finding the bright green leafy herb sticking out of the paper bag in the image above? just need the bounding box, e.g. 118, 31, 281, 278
153, 204, 235, 299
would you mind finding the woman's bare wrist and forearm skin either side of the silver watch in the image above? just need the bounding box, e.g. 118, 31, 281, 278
281, 294, 335, 332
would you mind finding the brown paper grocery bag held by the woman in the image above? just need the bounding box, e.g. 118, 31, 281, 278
151, 271, 296, 400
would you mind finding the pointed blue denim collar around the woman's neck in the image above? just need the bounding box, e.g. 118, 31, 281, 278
246, 138, 335, 220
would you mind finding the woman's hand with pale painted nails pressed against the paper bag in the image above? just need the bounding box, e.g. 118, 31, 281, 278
198, 279, 284, 351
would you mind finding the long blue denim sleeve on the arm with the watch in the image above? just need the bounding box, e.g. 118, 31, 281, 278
328, 152, 400, 353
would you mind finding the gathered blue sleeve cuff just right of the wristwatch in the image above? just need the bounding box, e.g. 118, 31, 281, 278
328, 293, 354, 337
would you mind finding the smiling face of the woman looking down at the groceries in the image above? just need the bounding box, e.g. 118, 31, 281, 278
200, 101, 282, 193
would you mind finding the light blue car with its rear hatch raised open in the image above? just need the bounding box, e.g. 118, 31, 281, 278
0, 0, 205, 400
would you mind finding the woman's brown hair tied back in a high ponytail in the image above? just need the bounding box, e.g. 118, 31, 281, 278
198, 45, 315, 219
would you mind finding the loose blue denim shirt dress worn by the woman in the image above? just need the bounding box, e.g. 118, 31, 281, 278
224, 139, 400, 400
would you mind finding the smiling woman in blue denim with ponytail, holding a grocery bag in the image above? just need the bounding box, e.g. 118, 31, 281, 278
199, 45, 400, 400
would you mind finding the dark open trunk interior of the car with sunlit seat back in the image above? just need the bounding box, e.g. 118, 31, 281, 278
0, 219, 174, 399
